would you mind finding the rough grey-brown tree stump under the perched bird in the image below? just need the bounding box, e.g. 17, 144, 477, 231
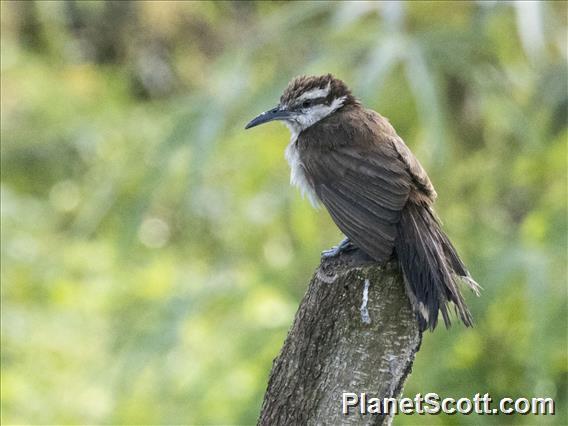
258, 251, 422, 426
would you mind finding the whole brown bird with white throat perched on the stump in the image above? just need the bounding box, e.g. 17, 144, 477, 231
245, 74, 480, 331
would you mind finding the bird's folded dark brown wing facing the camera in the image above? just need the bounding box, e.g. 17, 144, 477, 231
302, 146, 410, 261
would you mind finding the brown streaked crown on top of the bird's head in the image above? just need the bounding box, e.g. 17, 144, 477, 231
280, 74, 357, 105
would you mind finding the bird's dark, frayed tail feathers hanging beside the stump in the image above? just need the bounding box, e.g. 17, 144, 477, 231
395, 202, 480, 331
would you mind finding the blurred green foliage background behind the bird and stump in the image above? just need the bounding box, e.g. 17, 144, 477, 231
1, 1, 568, 425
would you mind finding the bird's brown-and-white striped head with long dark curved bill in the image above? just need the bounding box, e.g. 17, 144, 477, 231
245, 74, 357, 136
